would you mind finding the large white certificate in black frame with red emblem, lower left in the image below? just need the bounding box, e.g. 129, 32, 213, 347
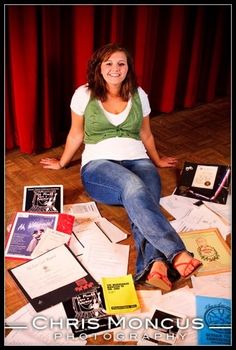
9, 244, 98, 311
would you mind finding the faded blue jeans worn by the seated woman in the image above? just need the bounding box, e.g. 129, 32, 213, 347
81, 159, 186, 281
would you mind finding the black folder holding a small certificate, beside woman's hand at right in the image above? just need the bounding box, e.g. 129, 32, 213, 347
173, 162, 231, 204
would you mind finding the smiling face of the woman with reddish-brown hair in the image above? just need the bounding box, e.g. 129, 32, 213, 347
101, 51, 128, 86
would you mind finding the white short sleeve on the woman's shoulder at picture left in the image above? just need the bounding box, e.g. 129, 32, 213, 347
70, 84, 90, 115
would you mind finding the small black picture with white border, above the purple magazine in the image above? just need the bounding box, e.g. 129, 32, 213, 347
22, 185, 63, 213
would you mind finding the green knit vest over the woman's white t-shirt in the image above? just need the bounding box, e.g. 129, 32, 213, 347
84, 92, 143, 143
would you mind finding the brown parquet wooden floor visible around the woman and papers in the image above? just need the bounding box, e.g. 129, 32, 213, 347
5, 98, 231, 345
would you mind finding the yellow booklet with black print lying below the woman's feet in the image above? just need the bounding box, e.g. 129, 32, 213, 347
101, 274, 140, 314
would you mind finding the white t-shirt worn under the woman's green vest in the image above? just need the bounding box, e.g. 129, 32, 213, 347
70, 84, 151, 166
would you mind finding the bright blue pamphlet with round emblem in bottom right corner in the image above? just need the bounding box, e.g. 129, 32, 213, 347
196, 296, 232, 345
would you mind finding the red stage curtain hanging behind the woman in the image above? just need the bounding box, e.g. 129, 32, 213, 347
5, 5, 231, 154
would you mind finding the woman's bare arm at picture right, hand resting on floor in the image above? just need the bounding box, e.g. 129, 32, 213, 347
140, 116, 178, 168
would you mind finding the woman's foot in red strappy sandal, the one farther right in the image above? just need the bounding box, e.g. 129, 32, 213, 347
173, 252, 202, 278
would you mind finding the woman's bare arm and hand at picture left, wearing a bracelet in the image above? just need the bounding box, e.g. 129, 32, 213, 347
40, 111, 84, 169
